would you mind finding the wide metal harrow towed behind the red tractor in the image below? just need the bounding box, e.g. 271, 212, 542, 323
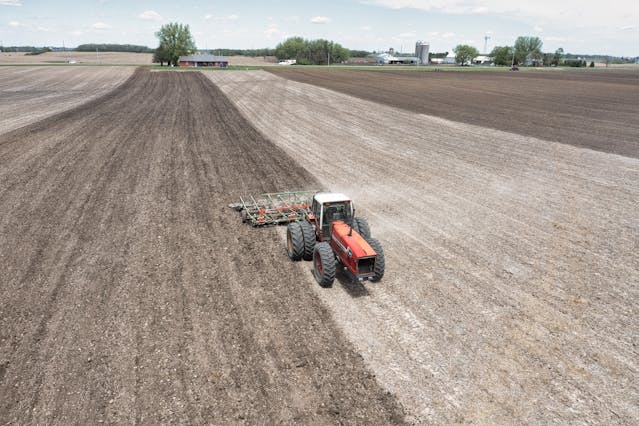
229, 191, 318, 226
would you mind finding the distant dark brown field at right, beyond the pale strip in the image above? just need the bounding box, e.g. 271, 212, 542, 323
269, 68, 639, 158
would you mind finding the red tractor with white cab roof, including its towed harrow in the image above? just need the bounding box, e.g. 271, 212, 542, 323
230, 191, 384, 287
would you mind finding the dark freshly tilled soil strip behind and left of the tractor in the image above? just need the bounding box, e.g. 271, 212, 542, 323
0, 72, 403, 424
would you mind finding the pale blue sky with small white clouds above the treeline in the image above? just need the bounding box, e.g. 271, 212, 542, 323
0, 0, 639, 57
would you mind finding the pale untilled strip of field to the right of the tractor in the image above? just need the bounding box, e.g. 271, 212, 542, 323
205, 71, 639, 425
